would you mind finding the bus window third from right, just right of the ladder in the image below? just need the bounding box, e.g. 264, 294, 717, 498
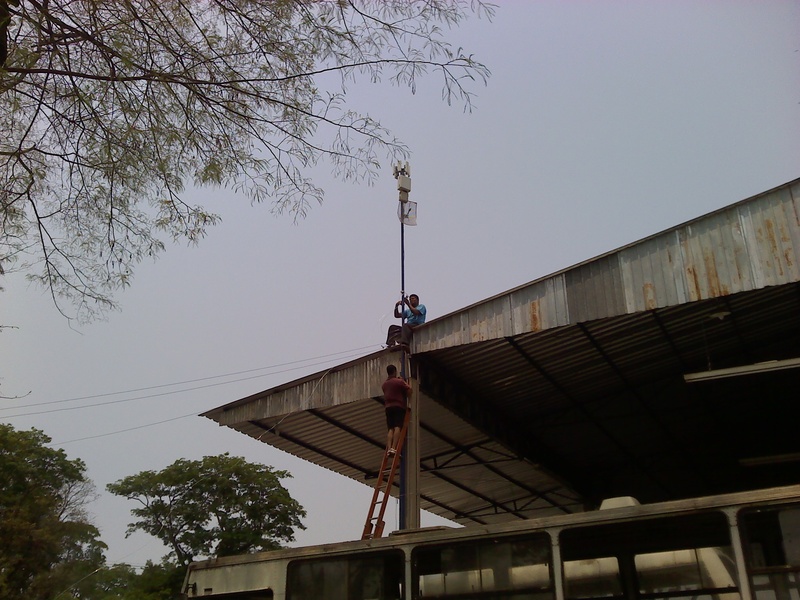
412, 534, 553, 600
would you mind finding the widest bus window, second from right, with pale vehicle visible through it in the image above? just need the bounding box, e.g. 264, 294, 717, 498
560, 513, 740, 600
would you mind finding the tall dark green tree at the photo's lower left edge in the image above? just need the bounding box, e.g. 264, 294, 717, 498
0, 424, 106, 600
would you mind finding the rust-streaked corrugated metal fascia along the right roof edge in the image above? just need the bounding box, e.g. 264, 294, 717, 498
415, 180, 800, 353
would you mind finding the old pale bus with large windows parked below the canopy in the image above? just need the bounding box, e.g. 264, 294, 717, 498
183, 485, 800, 600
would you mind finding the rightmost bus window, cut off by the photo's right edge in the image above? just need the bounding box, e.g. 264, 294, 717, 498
740, 505, 800, 600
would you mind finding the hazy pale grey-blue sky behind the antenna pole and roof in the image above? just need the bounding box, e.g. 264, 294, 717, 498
0, 0, 800, 566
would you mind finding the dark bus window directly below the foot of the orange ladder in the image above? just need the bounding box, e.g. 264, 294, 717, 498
286, 550, 404, 600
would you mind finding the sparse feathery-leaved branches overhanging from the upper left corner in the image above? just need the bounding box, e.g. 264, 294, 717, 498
0, 0, 493, 319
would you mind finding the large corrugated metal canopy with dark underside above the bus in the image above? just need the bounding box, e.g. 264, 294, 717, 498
202, 180, 800, 525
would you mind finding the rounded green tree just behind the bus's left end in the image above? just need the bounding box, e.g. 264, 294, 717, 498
107, 453, 306, 565
